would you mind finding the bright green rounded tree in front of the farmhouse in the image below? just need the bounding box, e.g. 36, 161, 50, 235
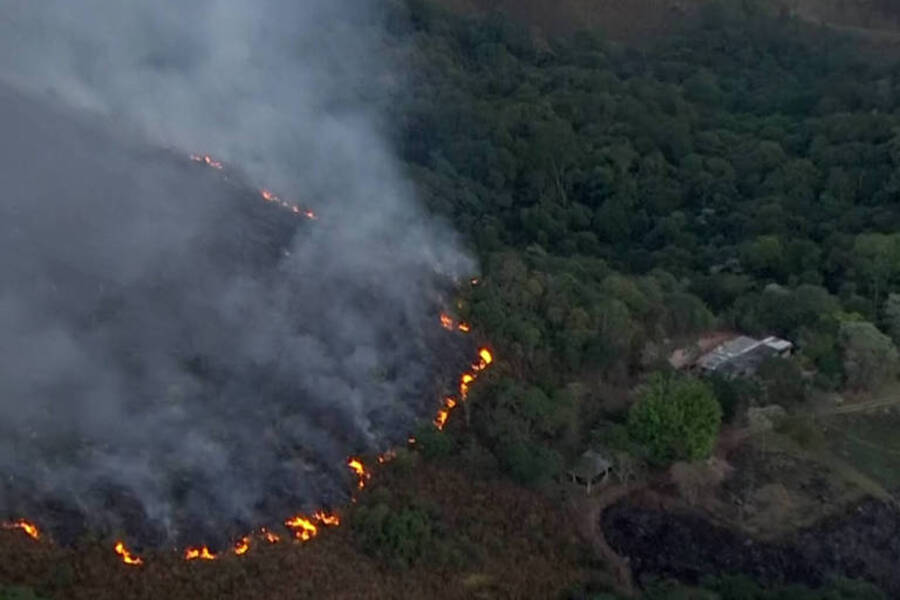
628, 373, 722, 463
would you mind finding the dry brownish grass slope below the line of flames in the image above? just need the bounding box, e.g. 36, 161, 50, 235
0, 465, 581, 600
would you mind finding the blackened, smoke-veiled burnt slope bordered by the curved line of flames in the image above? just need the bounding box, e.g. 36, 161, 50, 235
0, 67, 471, 544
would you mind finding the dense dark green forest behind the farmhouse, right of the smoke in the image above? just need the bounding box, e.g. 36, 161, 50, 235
366, 1, 900, 480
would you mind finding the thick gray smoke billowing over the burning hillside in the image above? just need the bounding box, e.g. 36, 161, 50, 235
0, 0, 471, 539
